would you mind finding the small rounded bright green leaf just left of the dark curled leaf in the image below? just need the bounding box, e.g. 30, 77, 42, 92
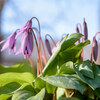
59, 61, 75, 74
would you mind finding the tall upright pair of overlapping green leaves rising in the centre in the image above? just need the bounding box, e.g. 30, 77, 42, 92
43, 33, 90, 76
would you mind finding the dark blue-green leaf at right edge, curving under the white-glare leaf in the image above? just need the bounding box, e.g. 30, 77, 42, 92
74, 64, 100, 90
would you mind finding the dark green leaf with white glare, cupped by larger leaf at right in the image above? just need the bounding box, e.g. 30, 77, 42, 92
77, 60, 94, 79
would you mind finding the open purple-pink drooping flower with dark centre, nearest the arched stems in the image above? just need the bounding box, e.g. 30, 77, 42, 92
16, 31, 33, 59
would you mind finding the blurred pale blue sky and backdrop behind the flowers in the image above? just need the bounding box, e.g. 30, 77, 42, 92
0, 0, 100, 65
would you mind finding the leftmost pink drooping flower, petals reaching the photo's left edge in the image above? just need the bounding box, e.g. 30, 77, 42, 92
0, 32, 16, 54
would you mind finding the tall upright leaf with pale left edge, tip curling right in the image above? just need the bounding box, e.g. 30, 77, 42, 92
43, 33, 83, 76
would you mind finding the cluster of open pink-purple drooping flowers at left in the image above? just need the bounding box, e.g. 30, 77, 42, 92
0, 19, 33, 58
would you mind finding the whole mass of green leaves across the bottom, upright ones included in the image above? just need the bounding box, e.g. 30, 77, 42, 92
0, 33, 100, 100
